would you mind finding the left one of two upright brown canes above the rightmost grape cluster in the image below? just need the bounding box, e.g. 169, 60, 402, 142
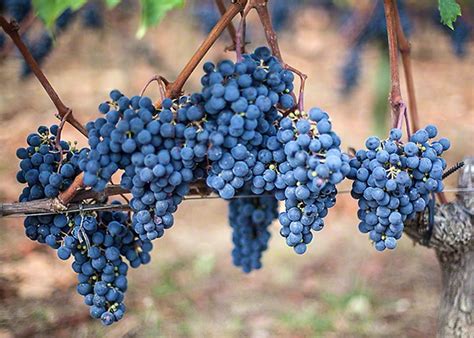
384, 0, 402, 127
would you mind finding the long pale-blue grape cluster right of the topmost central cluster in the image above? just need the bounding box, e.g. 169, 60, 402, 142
272, 108, 350, 254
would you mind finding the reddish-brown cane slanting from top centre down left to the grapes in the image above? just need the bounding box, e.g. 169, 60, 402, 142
156, 0, 248, 106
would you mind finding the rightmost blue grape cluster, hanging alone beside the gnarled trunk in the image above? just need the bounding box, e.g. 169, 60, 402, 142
348, 125, 450, 251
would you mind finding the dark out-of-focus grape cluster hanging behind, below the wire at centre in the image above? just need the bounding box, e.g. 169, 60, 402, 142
229, 196, 278, 273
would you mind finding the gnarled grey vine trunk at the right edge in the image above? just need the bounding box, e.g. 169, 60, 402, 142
405, 158, 474, 338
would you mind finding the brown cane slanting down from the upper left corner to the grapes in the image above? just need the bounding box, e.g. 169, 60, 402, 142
0, 16, 87, 137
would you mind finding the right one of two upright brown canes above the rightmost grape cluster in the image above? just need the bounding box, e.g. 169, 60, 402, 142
394, 0, 420, 132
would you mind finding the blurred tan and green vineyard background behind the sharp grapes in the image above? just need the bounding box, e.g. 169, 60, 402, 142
0, 0, 474, 338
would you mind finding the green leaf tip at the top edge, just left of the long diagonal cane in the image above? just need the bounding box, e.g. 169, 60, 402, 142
137, 0, 184, 38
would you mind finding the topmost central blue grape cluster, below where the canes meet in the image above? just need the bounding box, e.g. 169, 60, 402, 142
201, 47, 295, 199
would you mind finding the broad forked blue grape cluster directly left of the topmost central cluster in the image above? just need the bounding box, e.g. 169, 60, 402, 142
80, 90, 199, 240
